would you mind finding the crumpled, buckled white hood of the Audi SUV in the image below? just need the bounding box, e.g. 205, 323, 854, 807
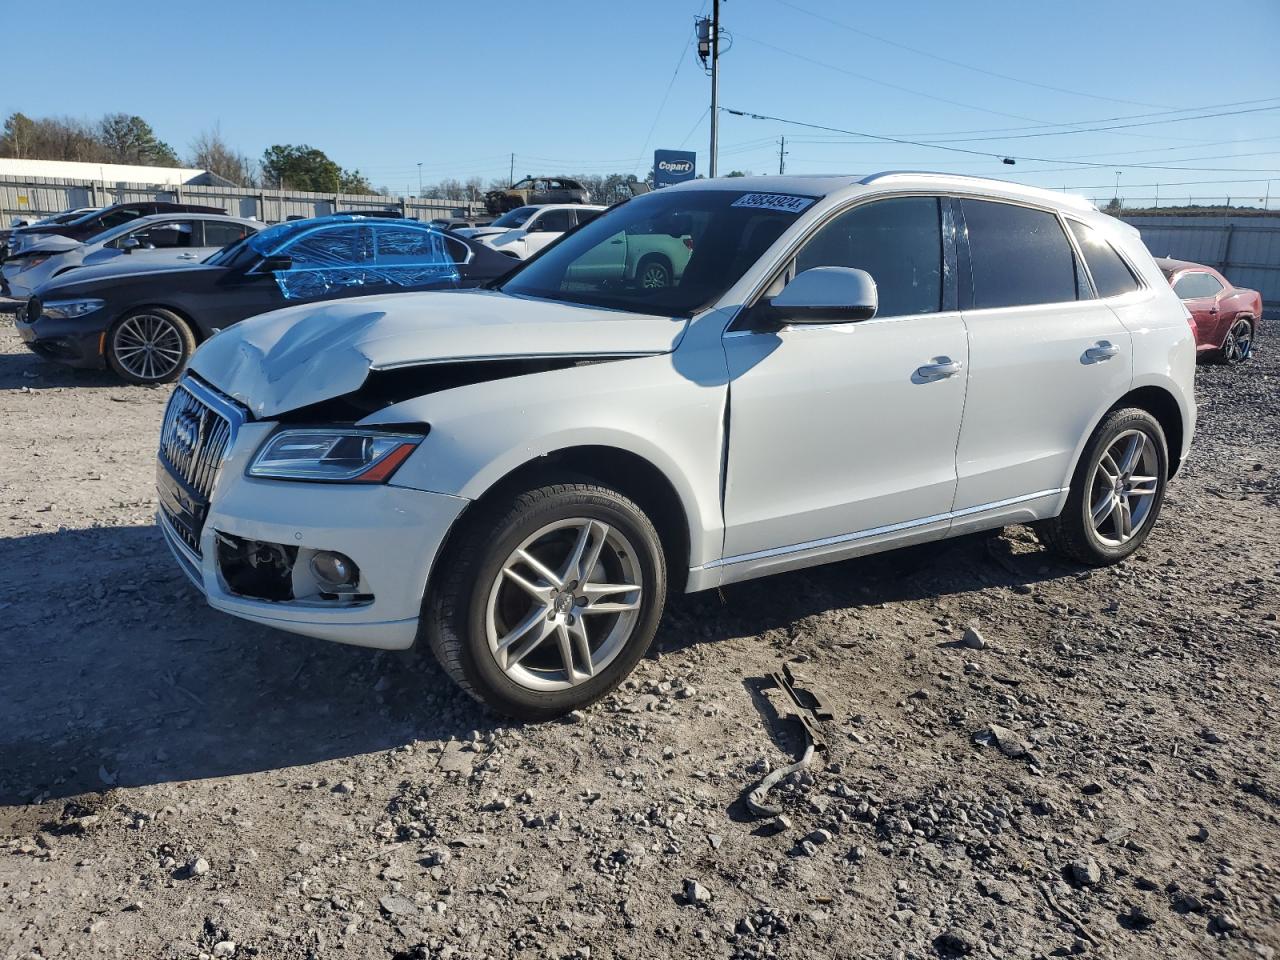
191, 291, 686, 417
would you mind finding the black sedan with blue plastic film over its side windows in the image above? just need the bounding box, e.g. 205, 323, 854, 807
17, 215, 513, 384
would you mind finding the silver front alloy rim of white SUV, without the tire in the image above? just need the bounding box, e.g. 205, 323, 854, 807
485, 517, 644, 691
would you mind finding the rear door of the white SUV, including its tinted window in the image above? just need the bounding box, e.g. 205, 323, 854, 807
952, 198, 1132, 525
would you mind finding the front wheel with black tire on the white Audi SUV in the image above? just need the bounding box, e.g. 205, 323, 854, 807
422, 483, 667, 721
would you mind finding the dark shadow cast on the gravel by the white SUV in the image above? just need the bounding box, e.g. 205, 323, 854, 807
0, 526, 1074, 804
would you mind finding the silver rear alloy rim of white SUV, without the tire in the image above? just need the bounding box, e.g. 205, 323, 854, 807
1089, 430, 1160, 547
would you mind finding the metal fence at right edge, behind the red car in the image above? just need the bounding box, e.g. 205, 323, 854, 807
1121, 215, 1280, 319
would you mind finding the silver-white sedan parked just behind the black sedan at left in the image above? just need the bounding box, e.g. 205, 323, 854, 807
4, 214, 262, 300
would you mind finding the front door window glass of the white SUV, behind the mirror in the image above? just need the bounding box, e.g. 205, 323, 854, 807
796, 197, 942, 316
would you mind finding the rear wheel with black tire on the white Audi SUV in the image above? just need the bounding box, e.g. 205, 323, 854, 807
1037, 407, 1169, 566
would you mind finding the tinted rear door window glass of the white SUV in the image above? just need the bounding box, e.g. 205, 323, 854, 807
961, 200, 1076, 310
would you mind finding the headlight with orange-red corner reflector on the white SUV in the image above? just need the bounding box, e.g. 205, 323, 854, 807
248, 428, 422, 484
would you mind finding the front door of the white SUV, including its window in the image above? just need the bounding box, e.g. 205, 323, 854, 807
722, 197, 968, 568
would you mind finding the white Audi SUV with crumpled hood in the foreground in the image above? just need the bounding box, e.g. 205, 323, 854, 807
157, 173, 1196, 719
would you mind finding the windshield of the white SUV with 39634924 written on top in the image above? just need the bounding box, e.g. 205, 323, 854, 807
499, 189, 815, 316
